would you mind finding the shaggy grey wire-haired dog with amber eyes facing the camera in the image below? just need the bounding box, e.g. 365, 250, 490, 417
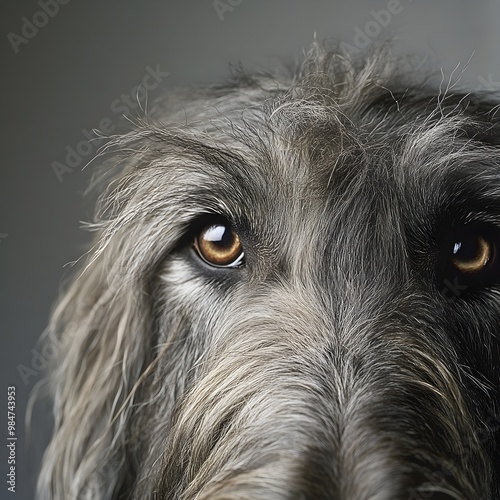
38, 43, 500, 500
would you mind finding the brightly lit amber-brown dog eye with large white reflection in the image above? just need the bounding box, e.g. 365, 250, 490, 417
194, 223, 244, 267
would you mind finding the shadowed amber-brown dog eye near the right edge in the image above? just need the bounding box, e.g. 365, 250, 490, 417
451, 234, 494, 274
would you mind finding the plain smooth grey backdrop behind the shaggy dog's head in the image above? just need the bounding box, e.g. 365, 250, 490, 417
0, 0, 500, 499
